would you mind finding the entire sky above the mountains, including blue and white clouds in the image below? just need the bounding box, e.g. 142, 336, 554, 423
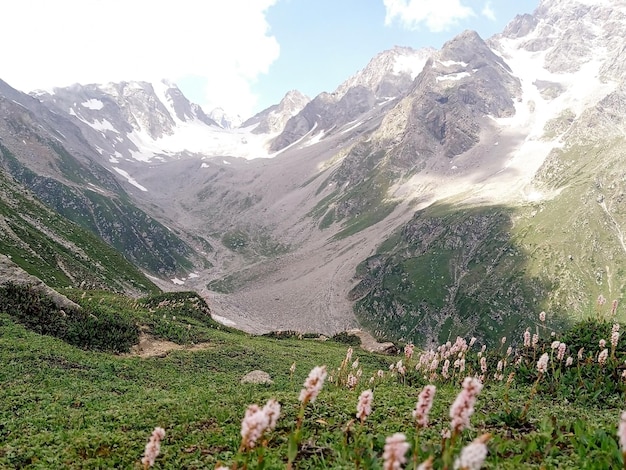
0, 0, 539, 118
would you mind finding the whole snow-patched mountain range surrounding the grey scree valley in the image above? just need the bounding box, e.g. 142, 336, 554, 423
0, 0, 626, 345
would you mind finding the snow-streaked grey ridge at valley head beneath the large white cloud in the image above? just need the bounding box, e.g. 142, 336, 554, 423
36, 81, 278, 164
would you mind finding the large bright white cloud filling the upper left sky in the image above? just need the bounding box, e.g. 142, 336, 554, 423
0, 0, 279, 116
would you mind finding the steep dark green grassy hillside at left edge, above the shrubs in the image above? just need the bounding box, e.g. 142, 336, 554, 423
0, 170, 160, 293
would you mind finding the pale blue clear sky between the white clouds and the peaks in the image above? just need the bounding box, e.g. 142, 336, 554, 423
246, 0, 539, 114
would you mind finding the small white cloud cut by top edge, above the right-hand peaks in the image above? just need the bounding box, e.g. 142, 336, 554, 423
383, 0, 475, 33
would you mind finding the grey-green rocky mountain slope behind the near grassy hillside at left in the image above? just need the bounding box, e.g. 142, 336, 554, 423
0, 82, 201, 276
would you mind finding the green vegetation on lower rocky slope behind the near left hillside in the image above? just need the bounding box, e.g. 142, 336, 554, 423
0, 142, 194, 275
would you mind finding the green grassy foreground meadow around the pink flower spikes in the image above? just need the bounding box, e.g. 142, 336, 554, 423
0, 292, 626, 469
